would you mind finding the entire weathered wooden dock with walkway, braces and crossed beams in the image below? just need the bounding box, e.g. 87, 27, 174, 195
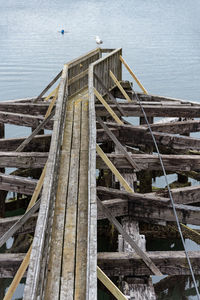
0, 48, 200, 300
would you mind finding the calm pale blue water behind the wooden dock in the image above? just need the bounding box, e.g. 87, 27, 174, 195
0, 0, 200, 299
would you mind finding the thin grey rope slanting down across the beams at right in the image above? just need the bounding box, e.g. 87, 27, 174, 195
132, 89, 200, 300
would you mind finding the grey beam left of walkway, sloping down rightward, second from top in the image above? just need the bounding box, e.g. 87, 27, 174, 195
0, 111, 53, 129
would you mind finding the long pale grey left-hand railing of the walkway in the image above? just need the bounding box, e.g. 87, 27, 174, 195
24, 65, 68, 300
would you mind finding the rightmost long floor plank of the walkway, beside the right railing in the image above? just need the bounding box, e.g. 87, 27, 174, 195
74, 100, 89, 299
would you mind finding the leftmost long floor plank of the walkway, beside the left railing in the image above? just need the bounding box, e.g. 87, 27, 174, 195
44, 101, 74, 300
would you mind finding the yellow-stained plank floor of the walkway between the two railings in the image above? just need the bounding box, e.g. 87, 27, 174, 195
44, 91, 89, 299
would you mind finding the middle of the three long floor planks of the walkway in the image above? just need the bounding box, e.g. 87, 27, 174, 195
60, 102, 81, 300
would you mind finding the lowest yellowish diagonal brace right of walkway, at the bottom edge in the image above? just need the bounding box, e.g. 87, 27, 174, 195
97, 267, 127, 300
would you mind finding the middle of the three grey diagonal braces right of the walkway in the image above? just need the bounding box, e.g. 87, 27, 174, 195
97, 117, 140, 171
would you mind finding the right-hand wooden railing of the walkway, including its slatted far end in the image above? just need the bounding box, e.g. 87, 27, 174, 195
87, 49, 122, 300
